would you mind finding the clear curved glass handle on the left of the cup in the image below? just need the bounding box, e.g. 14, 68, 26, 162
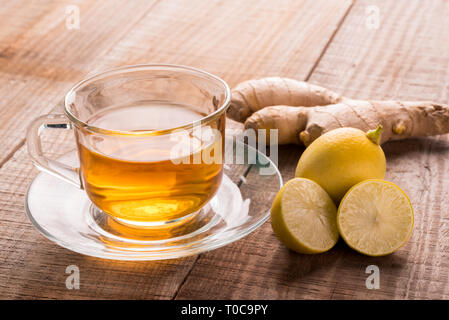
26, 114, 83, 189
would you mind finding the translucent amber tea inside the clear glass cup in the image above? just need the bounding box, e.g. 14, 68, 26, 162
76, 103, 225, 222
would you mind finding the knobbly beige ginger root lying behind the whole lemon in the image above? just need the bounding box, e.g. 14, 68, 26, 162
228, 78, 449, 146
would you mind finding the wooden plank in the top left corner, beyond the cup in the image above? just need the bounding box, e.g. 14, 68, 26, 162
0, 0, 159, 164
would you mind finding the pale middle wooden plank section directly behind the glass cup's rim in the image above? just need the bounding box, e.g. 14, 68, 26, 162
87, 0, 351, 86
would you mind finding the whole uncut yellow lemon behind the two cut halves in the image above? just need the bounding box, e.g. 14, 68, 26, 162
295, 128, 386, 203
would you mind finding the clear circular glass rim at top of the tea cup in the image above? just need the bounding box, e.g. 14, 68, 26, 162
64, 63, 231, 136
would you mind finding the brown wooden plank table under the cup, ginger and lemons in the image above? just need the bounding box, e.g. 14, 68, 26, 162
0, 0, 449, 299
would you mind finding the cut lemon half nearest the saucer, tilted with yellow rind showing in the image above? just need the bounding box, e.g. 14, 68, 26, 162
271, 178, 338, 254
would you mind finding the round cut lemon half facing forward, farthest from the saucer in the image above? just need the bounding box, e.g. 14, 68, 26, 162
337, 179, 414, 256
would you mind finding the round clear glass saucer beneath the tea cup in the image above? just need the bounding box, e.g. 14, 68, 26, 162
25, 138, 282, 260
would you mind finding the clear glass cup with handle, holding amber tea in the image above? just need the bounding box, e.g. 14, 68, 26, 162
27, 65, 230, 227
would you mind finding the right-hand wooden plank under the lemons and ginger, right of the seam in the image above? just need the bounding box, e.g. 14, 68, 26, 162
177, 0, 449, 299
